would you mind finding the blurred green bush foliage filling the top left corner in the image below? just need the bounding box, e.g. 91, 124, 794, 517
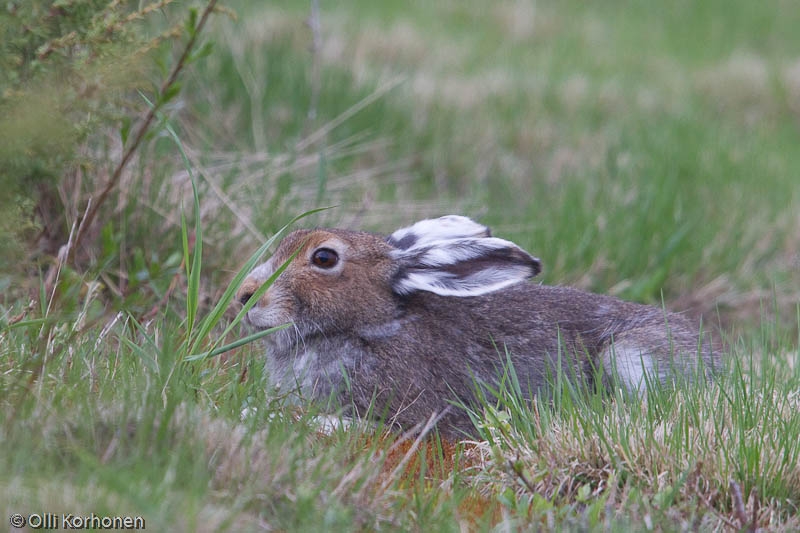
0, 0, 184, 270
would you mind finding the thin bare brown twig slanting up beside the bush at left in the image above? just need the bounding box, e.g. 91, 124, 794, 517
58, 0, 217, 268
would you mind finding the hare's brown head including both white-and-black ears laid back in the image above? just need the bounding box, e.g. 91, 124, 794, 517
238, 216, 540, 338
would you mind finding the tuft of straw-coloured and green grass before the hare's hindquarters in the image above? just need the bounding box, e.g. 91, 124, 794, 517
460, 376, 800, 531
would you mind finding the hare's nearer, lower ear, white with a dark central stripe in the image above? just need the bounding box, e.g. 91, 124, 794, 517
392, 237, 541, 296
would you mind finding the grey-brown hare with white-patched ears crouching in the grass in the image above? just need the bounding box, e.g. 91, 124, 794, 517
237, 215, 718, 436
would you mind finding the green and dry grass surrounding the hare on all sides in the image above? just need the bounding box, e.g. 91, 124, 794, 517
0, 0, 800, 531
